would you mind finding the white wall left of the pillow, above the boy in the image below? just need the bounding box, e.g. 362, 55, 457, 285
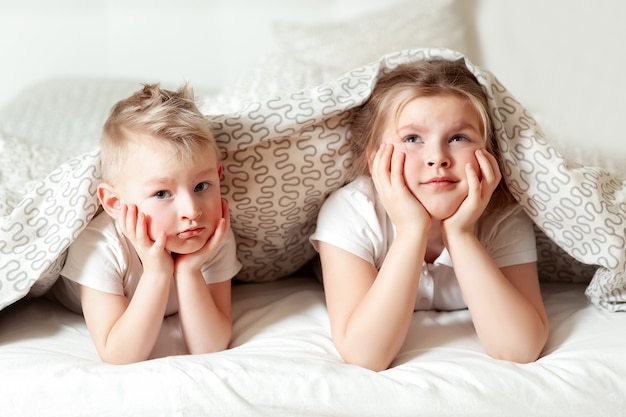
0, 0, 379, 106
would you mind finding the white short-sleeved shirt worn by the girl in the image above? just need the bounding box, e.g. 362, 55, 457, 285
310, 176, 537, 310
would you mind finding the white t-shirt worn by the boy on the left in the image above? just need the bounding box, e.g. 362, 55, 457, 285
51, 212, 241, 316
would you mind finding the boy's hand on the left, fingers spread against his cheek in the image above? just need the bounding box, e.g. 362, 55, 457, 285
118, 204, 174, 276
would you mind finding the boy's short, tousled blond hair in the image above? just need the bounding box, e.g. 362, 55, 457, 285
100, 83, 220, 182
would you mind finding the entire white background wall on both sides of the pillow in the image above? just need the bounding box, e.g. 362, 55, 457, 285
0, 0, 626, 157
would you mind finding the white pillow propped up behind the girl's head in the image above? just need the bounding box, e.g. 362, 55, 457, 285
274, 0, 469, 72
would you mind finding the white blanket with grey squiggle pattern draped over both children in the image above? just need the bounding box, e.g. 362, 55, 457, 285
0, 49, 626, 311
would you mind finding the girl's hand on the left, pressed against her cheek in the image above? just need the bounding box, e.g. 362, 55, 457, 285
371, 143, 431, 230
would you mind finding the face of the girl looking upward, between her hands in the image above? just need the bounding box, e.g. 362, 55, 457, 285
383, 95, 485, 220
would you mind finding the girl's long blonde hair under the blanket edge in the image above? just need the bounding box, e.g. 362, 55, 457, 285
348, 59, 513, 208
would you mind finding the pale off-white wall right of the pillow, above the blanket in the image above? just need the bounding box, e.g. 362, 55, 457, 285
477, 0, 626, 156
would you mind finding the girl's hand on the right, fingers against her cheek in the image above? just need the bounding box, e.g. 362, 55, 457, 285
441, 149, 502, 235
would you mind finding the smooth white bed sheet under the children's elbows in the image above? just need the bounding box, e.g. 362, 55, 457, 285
0, 276, 626, 417
